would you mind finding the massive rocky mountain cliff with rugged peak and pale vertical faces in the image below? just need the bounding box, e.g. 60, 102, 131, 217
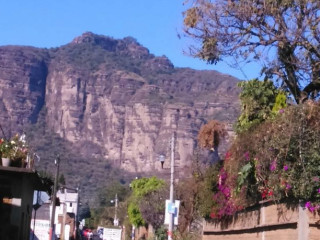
0, 33, 239, 172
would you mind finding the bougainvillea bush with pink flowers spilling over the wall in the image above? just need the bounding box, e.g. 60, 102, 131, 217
211, 102, 320, 218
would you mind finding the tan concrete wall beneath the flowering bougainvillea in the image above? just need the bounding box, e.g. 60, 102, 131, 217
202, 202, 320, 240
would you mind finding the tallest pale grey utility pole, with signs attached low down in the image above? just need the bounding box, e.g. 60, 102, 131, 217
168, 133, 175, 240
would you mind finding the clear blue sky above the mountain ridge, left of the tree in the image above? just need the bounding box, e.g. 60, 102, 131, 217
0, 0, 259, 79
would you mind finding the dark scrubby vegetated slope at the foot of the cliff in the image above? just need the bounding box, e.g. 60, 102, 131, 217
25, 109, 131, 206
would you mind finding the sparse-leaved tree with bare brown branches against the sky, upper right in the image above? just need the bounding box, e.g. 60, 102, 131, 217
184, 0, 320, 103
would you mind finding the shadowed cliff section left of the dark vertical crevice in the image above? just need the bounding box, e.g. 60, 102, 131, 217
0, 46, 48, 135
